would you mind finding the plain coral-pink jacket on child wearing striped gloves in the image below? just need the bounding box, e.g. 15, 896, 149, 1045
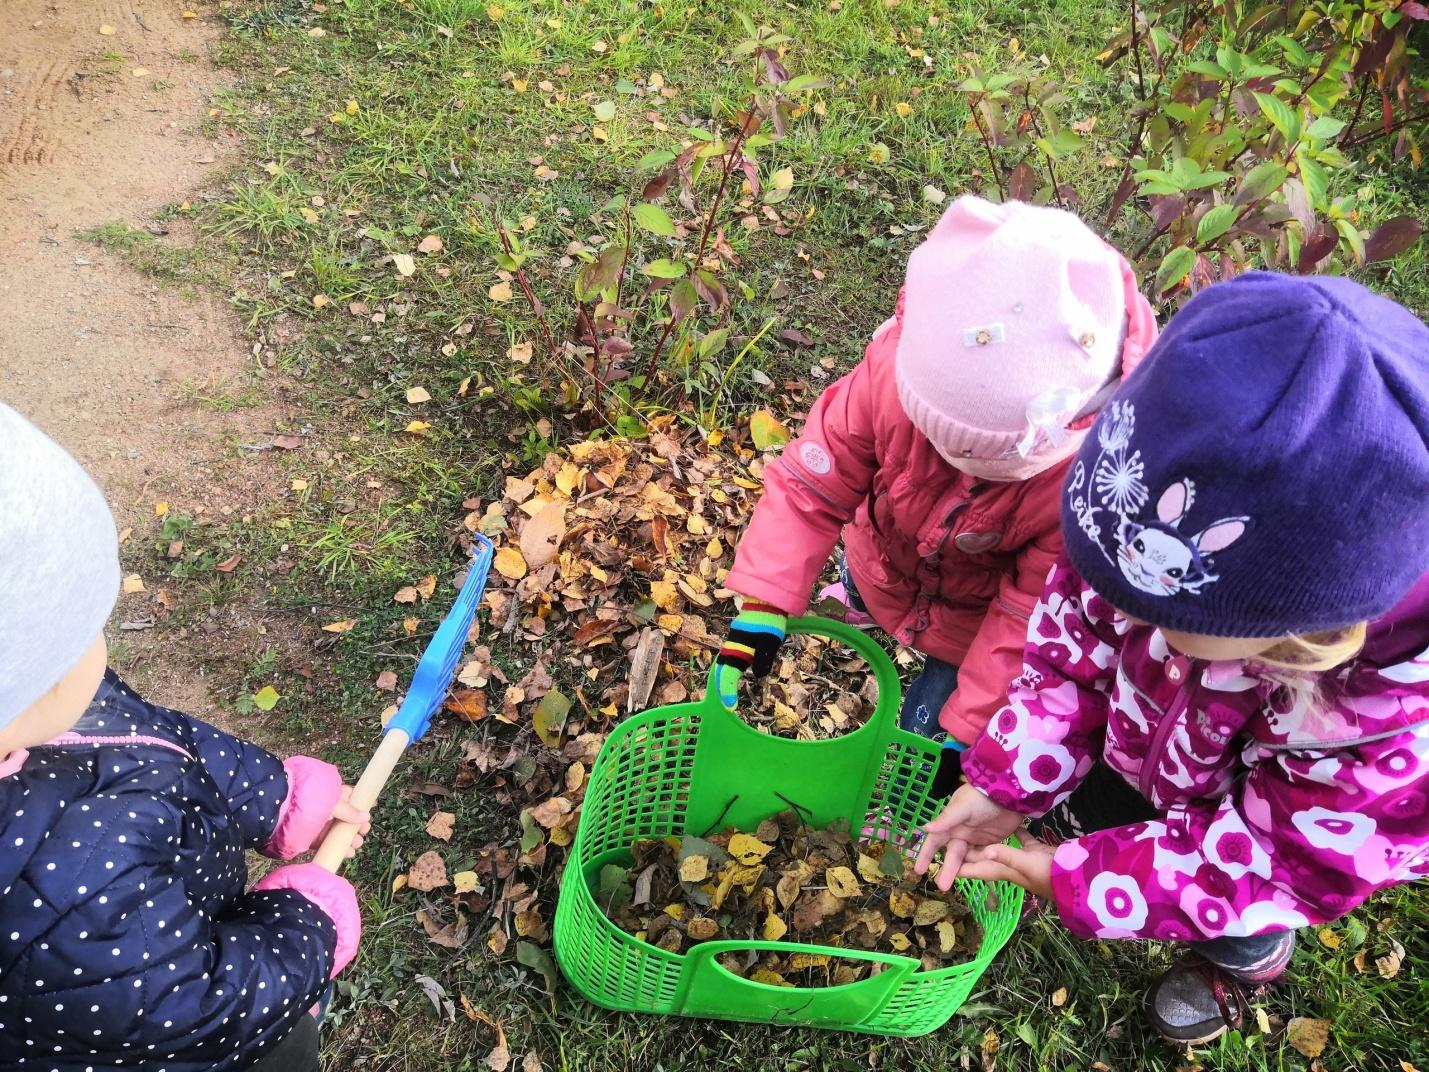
726, 294, 1156, 742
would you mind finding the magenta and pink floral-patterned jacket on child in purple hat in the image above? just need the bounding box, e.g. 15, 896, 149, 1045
963, 560, 1429, 941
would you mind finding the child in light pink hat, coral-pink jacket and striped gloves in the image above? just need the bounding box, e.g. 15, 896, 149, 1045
717, 197, 1156, 776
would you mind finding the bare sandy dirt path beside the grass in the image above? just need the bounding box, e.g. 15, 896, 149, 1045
0, 0, 282, 723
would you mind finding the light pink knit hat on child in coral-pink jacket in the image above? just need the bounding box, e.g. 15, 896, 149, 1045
896, 196, 1156, 480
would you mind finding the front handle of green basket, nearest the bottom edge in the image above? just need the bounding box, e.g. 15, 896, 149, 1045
676, 941, 919, 1028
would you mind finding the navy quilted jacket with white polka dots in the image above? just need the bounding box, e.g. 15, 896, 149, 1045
0, 670, 336, 1072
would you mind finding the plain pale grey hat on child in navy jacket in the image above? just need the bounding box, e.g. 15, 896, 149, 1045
0, 403, 119, 726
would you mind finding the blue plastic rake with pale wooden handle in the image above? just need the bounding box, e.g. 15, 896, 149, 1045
314, 536, 496, 873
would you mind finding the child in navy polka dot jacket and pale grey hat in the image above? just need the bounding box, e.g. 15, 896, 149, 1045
0, 406, 366, 1072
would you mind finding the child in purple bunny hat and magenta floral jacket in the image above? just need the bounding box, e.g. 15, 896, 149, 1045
917, 273, 1429, 1043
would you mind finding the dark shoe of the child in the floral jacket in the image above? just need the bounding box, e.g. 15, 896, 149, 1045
1146, 930, 1295, 1046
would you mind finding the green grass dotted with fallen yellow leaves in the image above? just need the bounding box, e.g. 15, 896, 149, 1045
93, 0, 1429, 1072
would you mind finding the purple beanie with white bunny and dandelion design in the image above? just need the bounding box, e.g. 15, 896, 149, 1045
1062, 272, 1429, 637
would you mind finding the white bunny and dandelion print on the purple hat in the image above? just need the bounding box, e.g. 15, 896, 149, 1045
1067, 402, 1250, 606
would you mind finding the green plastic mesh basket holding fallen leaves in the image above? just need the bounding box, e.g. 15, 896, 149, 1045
556, 617, 1022, 1035
